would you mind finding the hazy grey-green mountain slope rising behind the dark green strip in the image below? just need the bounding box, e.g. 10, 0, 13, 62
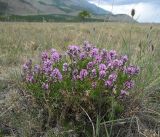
0, 0, 133, 22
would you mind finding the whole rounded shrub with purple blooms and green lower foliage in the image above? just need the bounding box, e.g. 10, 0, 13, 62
23, 42, 139, 132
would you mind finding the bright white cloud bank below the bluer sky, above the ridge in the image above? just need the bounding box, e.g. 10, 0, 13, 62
91, 0, 160, 22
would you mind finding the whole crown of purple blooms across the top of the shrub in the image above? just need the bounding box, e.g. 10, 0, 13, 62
23, 42, 140, 96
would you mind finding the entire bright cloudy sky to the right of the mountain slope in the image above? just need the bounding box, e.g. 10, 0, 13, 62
89, 0, 160, 23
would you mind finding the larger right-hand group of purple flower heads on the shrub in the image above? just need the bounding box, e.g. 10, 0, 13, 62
68, 42, 139, 94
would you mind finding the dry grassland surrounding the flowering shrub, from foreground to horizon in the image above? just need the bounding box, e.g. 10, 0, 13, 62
0, 22, 160, 137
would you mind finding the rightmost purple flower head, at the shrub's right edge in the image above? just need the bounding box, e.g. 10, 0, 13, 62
124, 66, 140, 75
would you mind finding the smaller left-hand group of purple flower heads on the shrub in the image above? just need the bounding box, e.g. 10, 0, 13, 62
23, 49, 63, 90
